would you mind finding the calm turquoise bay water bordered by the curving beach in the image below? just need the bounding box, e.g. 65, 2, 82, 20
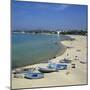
11, 33, 67, 68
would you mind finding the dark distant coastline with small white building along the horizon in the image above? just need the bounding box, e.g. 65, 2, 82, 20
12, 30, 87, 35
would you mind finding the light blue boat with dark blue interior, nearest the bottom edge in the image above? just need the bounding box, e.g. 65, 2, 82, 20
25, 71, 44, 79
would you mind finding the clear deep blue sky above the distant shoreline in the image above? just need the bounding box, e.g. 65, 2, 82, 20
11, 0, 87, 30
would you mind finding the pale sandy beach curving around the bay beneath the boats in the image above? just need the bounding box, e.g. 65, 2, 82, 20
12, 35, 88, 89
